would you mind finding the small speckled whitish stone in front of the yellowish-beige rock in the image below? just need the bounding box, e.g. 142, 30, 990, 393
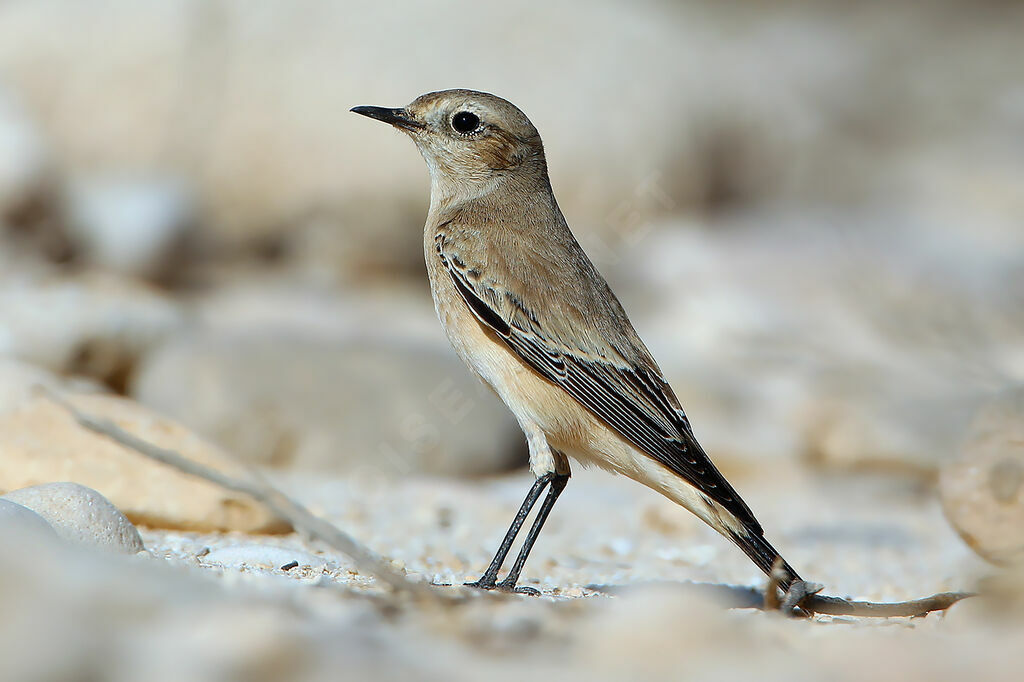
3, 483, 145, 554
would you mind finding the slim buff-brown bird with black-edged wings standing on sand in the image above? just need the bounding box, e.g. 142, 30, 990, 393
351, 89, 801, 595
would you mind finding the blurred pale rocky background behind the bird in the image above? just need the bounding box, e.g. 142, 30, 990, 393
0, 0, 1024, 675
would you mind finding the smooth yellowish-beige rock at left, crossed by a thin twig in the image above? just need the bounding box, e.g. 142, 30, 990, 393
0, 395, 289, 532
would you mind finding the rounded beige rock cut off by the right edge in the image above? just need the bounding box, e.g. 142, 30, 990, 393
939, 388, 1024, 563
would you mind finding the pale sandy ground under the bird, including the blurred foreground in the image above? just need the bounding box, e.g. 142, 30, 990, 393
0, 382, 1024, 682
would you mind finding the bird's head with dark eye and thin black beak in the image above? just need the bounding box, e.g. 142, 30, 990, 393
352, 90, 547, 196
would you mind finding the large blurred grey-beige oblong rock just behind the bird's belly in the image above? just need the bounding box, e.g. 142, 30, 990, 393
132, 329, 525, 476
